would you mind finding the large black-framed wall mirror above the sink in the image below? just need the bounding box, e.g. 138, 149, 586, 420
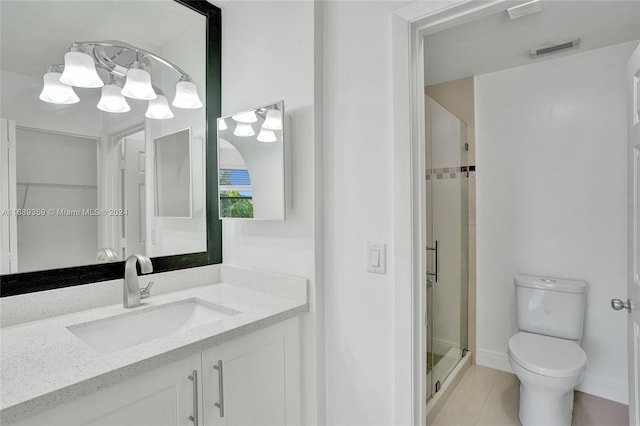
0, 0, 222, 297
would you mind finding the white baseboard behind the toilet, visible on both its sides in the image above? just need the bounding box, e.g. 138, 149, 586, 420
476, 349, 629, 404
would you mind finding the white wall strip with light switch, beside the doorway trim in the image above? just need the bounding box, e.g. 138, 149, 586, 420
323, 1, 410, 425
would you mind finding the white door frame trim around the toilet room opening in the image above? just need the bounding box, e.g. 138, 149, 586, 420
391, 0, 525, 425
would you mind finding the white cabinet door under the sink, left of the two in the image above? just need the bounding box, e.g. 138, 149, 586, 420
18, 354, 202, 426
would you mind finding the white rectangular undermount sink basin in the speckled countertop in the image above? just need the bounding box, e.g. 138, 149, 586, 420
67, 299, 239, 353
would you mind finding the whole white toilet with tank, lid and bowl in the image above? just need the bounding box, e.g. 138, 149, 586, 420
509, 275, 587, 426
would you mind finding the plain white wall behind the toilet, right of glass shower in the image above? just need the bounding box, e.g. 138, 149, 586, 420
475, 42, 637, 402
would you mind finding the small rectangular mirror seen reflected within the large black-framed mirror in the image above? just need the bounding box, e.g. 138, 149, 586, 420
153, 128, 192, 218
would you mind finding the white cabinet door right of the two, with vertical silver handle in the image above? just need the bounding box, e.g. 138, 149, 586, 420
202, 318, 301, 426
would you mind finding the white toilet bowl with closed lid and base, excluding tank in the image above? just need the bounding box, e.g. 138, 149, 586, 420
508, 331, 587, 426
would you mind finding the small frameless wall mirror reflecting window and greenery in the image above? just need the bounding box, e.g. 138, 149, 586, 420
218, 101, 285, 220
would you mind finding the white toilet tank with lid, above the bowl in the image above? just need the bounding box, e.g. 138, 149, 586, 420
514, 275, 587, 340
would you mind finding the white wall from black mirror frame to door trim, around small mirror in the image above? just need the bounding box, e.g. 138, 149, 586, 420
222, 1, 410, 425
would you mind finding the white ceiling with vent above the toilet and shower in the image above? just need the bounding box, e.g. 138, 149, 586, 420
424, 0, 640, 86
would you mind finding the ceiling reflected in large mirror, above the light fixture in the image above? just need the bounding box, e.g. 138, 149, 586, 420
0, 0, 205, 79
